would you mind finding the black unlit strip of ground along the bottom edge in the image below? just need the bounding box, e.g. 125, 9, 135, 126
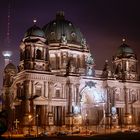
0, 133, 140, 140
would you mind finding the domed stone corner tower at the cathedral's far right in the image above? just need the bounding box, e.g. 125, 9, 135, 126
113, 39, 138, 81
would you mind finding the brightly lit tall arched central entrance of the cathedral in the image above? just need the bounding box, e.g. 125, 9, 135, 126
81, 86, 105, 125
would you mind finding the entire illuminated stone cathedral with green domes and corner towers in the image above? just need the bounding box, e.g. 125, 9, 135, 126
2, 11, 140, 132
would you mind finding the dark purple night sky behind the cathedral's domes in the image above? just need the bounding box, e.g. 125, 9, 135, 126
0, 0, 140, 85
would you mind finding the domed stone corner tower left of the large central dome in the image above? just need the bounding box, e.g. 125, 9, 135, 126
18, 21, 49, 72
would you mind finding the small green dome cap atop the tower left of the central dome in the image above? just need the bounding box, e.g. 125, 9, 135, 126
24, 25, 45, 38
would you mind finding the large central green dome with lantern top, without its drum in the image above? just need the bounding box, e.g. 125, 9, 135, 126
43, 11, 86, 46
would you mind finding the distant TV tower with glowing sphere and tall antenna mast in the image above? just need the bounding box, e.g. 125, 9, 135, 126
2, 0, 12, 66
